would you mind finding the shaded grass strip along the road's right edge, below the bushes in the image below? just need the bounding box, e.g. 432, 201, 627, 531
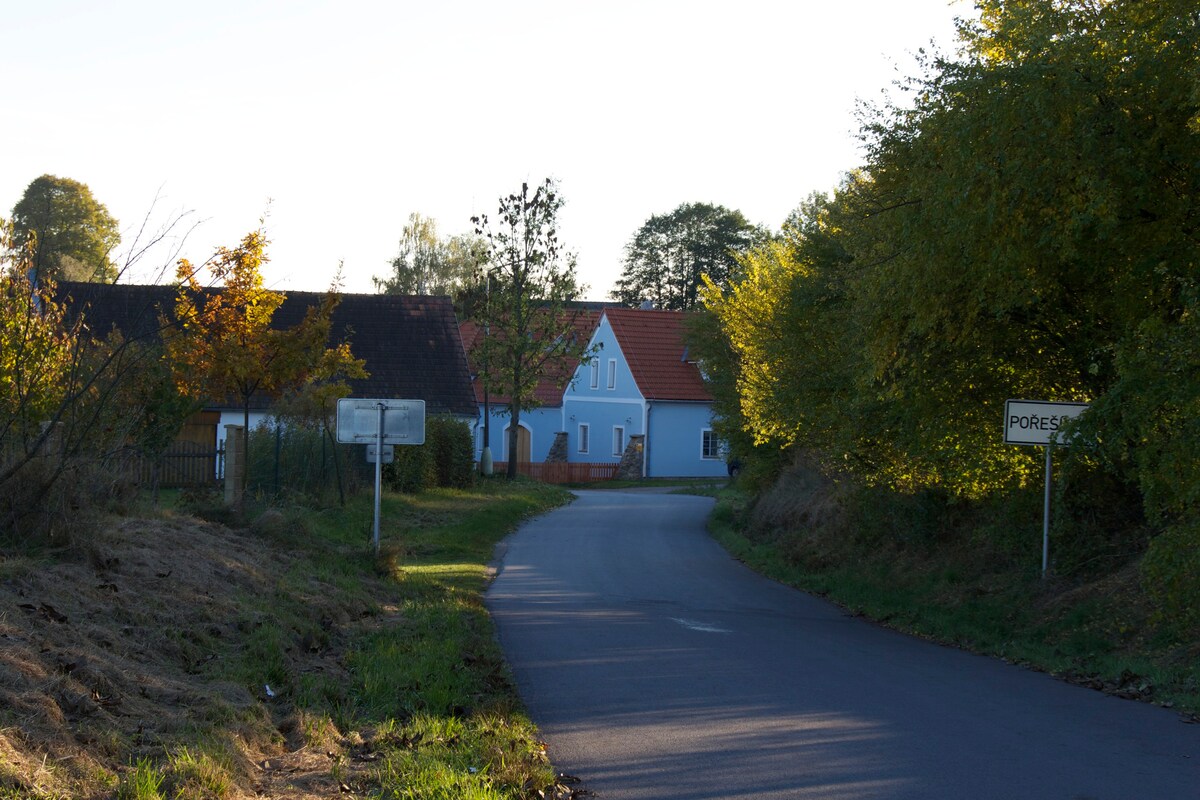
710, 489, 1200, 720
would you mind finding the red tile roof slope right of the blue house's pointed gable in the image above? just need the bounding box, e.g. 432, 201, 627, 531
604, 308, 713, 402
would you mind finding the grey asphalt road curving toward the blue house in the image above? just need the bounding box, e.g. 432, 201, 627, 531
487, 492, 1200, 800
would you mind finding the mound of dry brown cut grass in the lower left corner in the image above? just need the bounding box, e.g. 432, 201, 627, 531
0, 517, 381, 798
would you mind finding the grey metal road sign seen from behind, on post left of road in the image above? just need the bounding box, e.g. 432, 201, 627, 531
337, 397, 425, 555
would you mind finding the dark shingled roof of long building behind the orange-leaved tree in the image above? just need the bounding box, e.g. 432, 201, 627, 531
58, 282, 476, 417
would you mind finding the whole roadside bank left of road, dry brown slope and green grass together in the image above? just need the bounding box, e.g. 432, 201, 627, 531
0, 480, 569, 800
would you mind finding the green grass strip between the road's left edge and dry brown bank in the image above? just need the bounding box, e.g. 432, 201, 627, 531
247, 481, 569, 799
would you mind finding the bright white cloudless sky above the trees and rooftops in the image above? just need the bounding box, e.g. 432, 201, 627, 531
0, 0, 973, 299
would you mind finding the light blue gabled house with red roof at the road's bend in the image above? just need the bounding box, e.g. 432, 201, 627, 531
559, 308, 726, 477
